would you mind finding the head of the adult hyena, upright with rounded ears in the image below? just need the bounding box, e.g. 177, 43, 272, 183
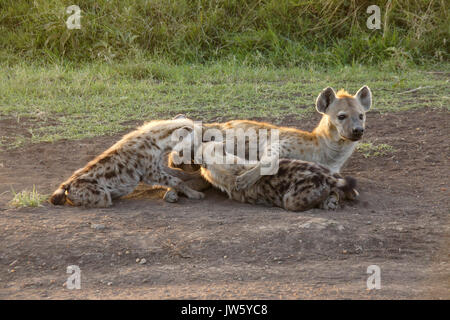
316, 86, 372, 141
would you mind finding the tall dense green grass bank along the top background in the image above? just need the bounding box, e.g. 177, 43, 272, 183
0, 0, 450, 66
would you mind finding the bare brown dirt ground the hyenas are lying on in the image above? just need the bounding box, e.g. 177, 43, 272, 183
0, 110, 450, 299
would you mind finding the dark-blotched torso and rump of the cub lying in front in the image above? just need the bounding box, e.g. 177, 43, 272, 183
231, 159, 357, 211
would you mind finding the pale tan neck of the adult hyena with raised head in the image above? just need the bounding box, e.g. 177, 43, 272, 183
313, 115, 357, 172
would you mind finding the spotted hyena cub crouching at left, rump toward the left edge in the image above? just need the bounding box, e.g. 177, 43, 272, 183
50, 119, 204, 207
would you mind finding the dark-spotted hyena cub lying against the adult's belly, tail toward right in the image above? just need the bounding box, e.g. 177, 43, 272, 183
201, 142, 358, 211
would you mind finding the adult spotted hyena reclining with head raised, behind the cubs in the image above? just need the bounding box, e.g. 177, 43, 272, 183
200, 86, 372, 190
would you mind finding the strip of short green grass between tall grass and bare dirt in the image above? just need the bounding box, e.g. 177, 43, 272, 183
0, 60, 450, 149
